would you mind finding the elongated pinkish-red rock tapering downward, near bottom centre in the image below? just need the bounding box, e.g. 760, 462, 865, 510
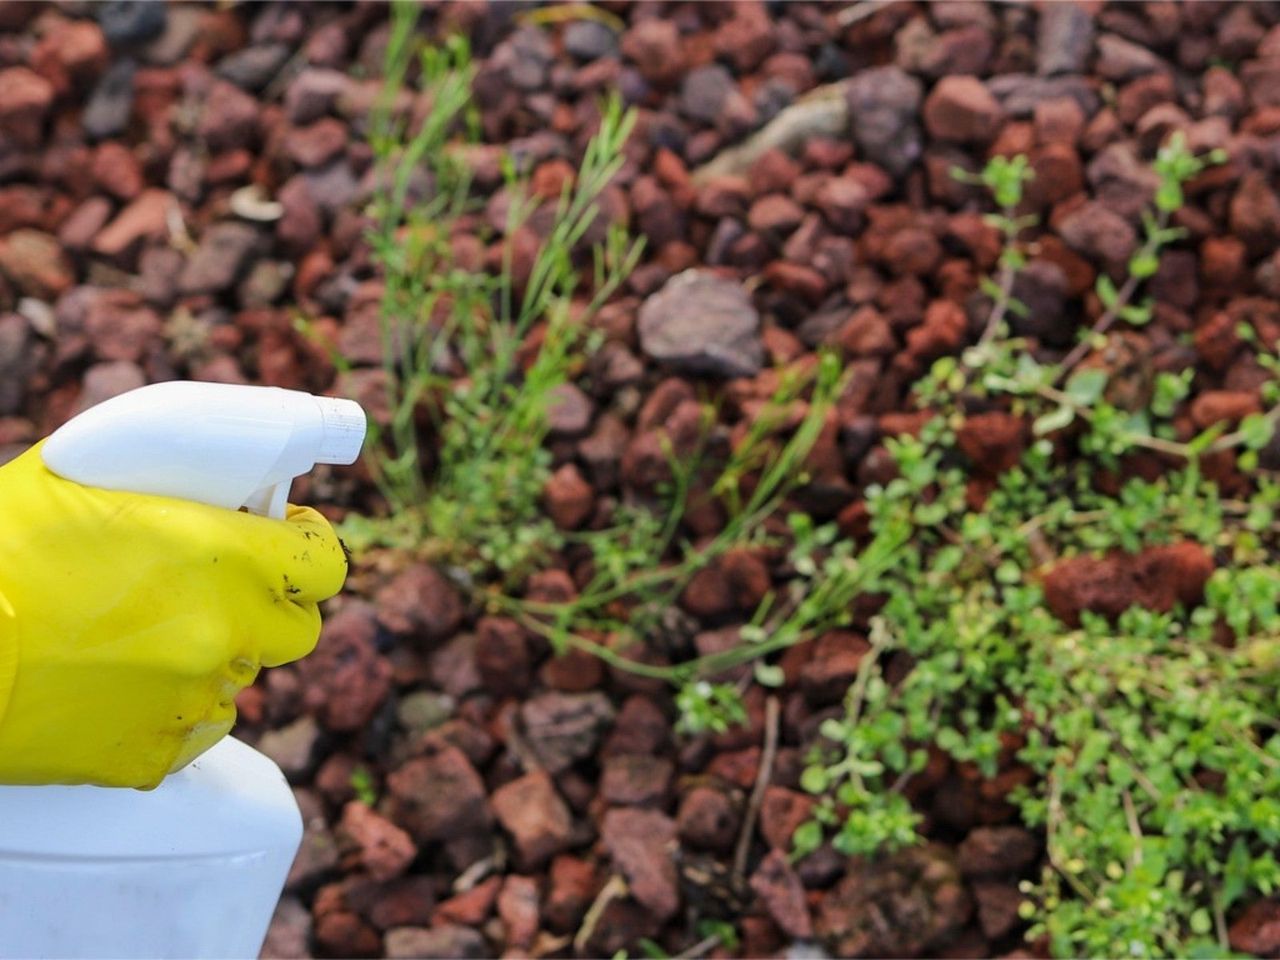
600, 808, 680, 923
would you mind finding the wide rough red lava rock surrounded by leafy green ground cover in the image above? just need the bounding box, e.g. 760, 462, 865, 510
1044, 543, 1213, 627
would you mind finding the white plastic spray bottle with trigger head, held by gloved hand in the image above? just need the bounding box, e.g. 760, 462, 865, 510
0, 381, 365, 957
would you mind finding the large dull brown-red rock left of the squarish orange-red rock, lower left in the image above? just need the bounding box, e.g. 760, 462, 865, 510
387, 746, 493, 844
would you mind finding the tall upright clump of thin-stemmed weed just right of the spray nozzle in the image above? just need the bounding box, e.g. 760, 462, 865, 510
355, 4, 641, 580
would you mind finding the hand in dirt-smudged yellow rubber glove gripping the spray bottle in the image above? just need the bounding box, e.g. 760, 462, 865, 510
0, 445, 347, 788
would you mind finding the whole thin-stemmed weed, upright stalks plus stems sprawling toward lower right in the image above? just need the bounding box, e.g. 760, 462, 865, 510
344, 5, 906, 733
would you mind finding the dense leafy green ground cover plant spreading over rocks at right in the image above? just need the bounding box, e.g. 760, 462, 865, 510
795, 138, 1280, 956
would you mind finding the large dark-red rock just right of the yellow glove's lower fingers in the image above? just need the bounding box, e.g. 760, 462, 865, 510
298, 602, 392, 731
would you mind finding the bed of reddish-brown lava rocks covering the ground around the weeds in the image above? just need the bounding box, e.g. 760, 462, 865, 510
0, 0, 1280, 957
